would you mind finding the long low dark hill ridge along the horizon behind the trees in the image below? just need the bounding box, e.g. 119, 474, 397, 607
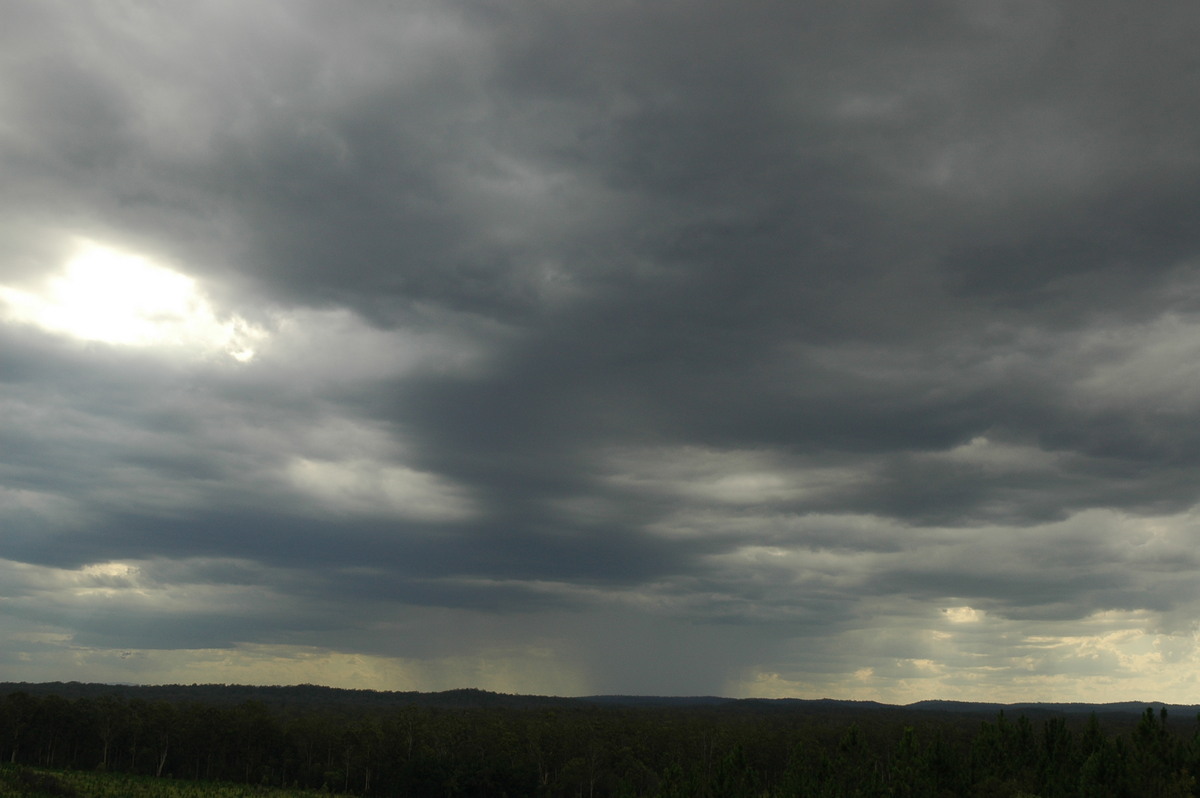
0, 682, 1200, 718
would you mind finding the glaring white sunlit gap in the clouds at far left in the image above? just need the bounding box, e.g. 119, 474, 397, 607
0, 242, 263, 362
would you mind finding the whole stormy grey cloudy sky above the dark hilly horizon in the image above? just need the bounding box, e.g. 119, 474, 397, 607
0, 0, 1200, 703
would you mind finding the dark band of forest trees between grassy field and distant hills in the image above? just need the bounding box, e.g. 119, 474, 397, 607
0, 692, 1200, 798
